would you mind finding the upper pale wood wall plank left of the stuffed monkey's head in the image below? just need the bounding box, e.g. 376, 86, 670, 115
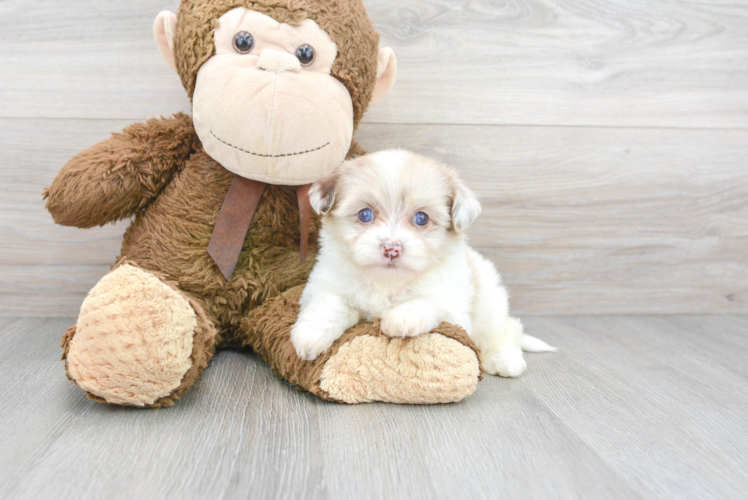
0, 0, 190, 120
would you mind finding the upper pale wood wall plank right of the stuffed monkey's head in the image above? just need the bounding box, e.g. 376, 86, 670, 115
367, 0, 748, 128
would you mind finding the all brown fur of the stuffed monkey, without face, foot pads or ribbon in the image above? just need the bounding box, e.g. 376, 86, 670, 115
44, 0, 476, 407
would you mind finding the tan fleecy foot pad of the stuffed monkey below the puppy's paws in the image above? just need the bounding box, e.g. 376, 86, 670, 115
320, 333, 480, 404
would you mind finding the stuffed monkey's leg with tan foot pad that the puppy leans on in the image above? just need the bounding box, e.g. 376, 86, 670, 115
242, 287, 480, 404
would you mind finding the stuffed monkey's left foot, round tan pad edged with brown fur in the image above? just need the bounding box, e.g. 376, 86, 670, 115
63, 263, 216, 408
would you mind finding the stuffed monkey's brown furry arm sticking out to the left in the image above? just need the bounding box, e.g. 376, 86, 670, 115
44, 113, 200, 228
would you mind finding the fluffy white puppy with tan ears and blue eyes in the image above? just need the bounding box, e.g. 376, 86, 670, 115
291, 150, 555, 377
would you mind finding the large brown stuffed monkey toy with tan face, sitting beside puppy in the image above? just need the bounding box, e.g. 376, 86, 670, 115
44, 0, 480, 408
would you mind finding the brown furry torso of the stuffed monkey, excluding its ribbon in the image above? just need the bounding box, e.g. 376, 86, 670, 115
119, 152, 317, 347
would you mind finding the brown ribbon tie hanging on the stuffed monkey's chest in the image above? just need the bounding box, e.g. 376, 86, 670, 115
208, 175, 312, 281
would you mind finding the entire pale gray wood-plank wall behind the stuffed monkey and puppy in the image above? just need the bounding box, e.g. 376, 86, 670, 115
0, 0, 748, 315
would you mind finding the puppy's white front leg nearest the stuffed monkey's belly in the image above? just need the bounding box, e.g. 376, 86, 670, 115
291, 293, 360, 361
